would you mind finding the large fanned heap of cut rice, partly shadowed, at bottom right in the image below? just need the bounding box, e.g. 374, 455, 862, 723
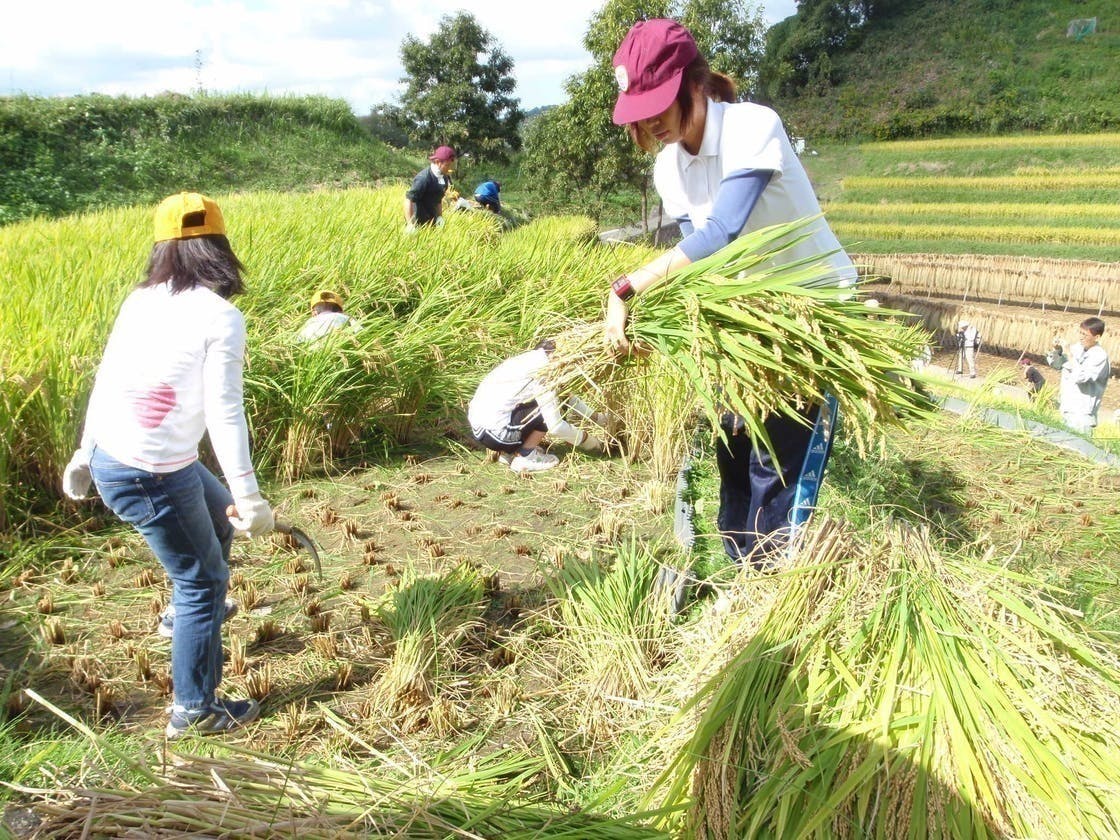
656, 523, 1120, 838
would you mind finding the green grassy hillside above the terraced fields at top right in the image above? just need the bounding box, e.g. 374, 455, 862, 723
774, 0, 1120, 140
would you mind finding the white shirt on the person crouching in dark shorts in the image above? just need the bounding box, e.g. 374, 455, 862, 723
467, 349, 585, 446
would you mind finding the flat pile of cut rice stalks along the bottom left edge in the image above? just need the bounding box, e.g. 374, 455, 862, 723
20, 730, 668, 840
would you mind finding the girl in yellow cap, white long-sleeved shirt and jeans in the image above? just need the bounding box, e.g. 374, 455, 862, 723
63, 193, 274, 738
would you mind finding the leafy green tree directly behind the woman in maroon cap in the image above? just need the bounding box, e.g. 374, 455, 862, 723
524, 0, 764, 227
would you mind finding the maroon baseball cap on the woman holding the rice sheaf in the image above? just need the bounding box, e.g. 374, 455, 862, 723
612, 18, 700, 125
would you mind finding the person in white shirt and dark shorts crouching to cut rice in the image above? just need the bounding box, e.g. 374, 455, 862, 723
467, 340, 606, 473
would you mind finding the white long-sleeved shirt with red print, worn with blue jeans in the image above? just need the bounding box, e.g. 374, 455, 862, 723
82, 283, 259, 498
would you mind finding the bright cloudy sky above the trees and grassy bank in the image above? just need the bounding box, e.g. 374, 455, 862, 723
0, 0, 795, 114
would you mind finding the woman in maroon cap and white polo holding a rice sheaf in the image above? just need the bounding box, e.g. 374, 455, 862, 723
606, 19, 856, 563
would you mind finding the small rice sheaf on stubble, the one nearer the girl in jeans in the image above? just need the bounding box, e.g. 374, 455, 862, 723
375, 566, 486, 728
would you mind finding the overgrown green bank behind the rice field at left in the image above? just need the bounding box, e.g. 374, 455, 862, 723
0, 94, 418, 224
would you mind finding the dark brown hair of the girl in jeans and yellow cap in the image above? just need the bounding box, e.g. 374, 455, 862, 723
140, 213, 245, 299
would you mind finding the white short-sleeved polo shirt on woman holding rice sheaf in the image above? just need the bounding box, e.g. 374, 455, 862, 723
653, 100, 856, 284
